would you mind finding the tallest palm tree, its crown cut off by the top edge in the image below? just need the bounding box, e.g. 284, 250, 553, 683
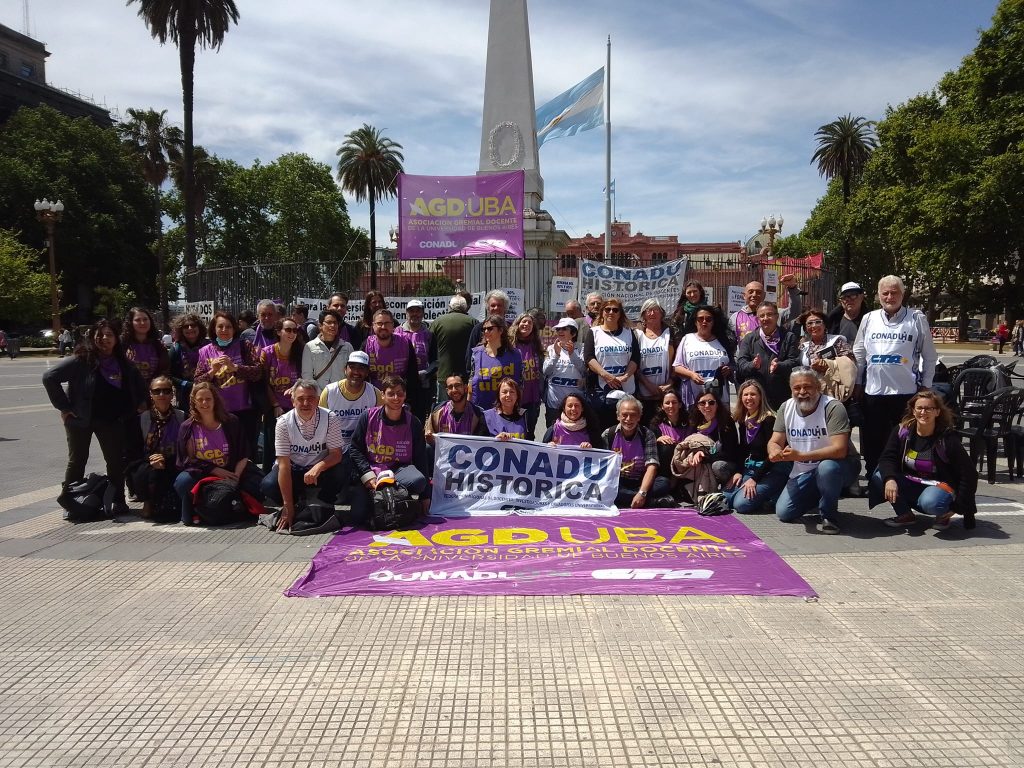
128, 0, 239, 271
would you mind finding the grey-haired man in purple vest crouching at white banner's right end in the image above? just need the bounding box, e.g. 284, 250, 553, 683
602, 394, 670, 509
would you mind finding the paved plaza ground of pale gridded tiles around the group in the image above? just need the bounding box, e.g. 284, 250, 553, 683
0, 349, 1024, 768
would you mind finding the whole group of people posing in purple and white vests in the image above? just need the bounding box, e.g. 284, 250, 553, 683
43, 275, 977, 534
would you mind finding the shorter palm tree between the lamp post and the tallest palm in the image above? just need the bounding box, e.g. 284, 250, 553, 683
118, 108, 183, 328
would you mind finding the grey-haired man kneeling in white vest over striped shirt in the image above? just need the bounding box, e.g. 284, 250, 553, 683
260, 379, 351, 530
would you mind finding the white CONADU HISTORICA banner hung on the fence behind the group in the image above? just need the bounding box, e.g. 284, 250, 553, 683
580, 259, 686, 319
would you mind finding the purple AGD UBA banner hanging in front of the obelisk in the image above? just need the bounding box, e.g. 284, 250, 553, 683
398, 171, 525, 259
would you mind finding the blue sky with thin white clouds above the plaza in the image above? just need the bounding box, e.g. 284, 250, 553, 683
0, 0, 996, 242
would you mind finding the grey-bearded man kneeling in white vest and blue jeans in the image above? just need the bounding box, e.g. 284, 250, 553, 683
768, 367, 860, 534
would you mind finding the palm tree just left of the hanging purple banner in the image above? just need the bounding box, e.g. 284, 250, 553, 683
337, 123, 406, 290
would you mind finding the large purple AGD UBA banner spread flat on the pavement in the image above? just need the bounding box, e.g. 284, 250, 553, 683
285, 509, 815, 597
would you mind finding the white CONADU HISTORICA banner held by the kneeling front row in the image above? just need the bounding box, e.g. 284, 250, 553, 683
430, 434, 622, 517
